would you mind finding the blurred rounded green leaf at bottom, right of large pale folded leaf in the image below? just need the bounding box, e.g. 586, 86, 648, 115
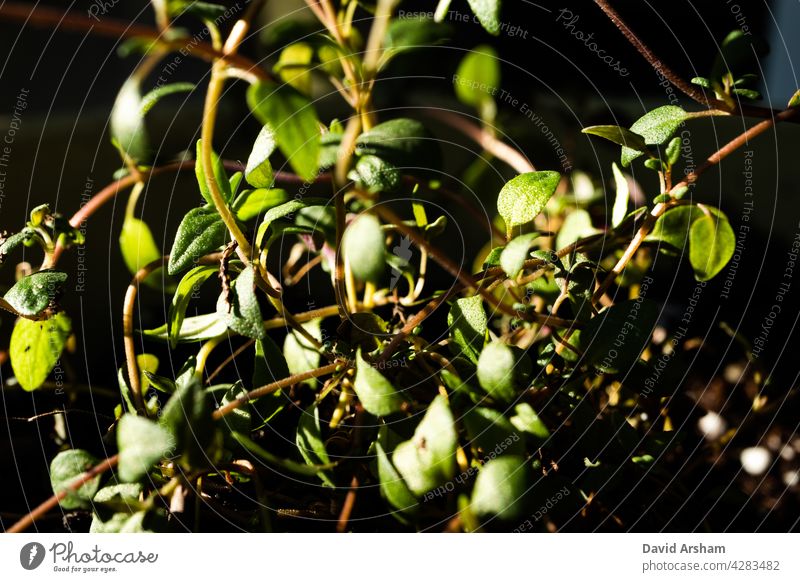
471, 455, 531, 520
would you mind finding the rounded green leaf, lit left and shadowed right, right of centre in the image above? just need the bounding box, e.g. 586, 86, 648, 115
478, 341, 531, 403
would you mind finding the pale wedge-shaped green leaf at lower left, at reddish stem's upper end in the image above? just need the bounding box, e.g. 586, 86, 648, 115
117, 414, 175, 483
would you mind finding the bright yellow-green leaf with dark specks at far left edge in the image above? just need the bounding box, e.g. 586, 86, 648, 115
9, 313, 72, 392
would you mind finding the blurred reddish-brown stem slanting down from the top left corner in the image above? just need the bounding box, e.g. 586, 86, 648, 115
0, 2, 270, 79
